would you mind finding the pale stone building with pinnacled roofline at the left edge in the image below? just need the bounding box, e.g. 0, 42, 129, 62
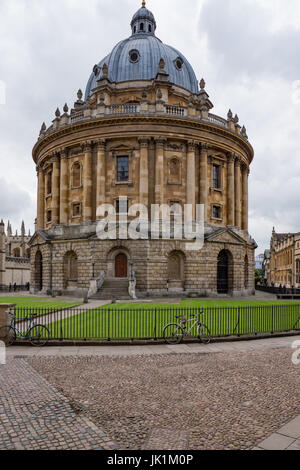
0, 220, 31, 290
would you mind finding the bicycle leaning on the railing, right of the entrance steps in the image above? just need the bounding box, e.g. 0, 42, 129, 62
163, 312, 211, 344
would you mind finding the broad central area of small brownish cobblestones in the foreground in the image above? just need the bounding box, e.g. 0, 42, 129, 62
26, 346, 300, 450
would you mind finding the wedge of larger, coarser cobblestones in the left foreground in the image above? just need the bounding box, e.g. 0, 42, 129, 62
0, 358, 116, 450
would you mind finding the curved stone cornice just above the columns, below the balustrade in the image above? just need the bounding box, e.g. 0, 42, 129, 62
33, 115, 254, 163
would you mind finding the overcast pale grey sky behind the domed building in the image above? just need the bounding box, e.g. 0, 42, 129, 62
0, 0, 300, 252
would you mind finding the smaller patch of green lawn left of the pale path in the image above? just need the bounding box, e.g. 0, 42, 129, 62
0, 297, 81, 318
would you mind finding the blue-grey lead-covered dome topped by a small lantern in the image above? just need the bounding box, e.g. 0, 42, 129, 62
85, 2, 199, 99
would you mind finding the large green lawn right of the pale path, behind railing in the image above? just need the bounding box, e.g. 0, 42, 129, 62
48, 300, 300, 340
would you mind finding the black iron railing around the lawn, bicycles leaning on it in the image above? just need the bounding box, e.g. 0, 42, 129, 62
15, 303, 300, 341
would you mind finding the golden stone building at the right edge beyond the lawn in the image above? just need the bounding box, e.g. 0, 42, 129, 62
267, 228, 300, 288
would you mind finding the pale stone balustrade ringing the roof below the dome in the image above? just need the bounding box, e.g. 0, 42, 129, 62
40, 102, 248, 140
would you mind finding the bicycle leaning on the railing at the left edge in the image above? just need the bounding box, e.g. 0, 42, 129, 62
0, 312, 50, 346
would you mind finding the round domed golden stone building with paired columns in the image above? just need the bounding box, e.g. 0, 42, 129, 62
31, 2, 256, 298
